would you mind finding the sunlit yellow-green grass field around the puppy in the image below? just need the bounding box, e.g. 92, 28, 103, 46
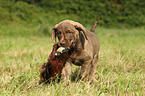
0, 25, 145, 96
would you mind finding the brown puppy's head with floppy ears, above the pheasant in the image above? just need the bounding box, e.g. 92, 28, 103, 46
52, 20, 87, 47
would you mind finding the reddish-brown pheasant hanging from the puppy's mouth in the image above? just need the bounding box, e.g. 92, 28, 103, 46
39, 44, 71, 83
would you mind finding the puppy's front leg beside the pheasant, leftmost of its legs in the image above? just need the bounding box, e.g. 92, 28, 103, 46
61, 62, 71, 82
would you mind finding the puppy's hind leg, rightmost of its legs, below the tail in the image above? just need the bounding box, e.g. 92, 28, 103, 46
89, 54, 98, 83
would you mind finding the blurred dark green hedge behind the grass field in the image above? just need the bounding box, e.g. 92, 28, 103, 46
0, 0, 145, 27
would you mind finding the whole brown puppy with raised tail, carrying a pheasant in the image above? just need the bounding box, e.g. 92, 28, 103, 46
52, 20, 100, 83
